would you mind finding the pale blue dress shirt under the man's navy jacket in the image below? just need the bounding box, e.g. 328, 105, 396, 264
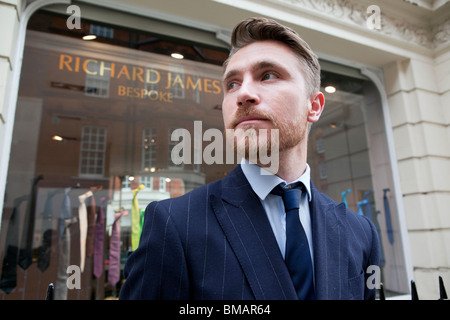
241, 160, 314, 266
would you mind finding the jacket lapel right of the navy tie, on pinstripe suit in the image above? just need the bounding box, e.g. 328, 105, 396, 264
310, 185, 349, 300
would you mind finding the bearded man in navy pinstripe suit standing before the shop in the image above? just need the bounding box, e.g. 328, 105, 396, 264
120, 18, 379, 300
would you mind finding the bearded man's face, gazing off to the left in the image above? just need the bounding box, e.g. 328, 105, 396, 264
222, 41, 321, 158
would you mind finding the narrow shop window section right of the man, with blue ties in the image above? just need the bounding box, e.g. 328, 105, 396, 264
308, 69, 409, 295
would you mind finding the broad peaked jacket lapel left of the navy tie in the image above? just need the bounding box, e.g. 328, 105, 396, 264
211, 166, 296, 300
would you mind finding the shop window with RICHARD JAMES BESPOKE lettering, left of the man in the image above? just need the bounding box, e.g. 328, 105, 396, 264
0, 8, 229, 300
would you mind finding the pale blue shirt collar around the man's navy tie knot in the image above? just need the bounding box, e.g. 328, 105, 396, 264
241, 159, 311, 201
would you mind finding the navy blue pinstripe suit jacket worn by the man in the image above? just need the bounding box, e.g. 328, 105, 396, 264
120, 166, 379, 300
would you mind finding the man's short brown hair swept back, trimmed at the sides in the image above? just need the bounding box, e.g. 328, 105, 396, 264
223, 17, 320, 96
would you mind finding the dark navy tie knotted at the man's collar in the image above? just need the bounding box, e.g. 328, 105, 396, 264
272, 183, 315, 300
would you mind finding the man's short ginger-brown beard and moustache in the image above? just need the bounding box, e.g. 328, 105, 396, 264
225, 108, 308, 164
